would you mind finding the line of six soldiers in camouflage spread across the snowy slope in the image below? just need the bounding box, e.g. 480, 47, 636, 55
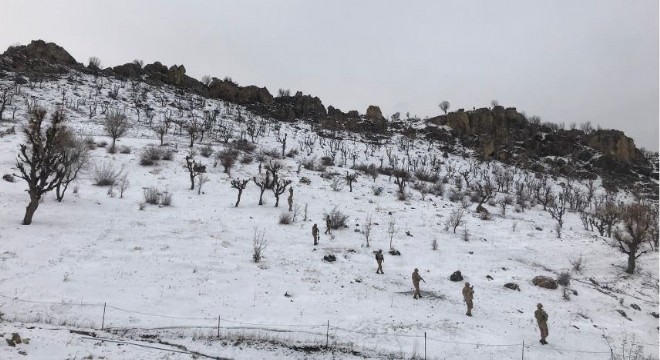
312, 224, 548, 345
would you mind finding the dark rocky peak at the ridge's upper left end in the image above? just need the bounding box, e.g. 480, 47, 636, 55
0, 40, 82, 73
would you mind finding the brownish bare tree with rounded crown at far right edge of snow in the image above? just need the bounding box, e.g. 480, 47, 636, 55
614, 203, 658, 274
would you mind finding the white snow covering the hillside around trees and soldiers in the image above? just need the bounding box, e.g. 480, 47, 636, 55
0, 71, 658, 359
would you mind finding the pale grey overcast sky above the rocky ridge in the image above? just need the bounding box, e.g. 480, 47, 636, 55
0, 0, 659, 151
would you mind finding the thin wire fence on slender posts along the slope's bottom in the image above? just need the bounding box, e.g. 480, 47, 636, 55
0, 294, 658, 360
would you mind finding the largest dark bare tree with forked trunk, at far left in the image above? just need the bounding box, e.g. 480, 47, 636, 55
16, 107, 66, 225
